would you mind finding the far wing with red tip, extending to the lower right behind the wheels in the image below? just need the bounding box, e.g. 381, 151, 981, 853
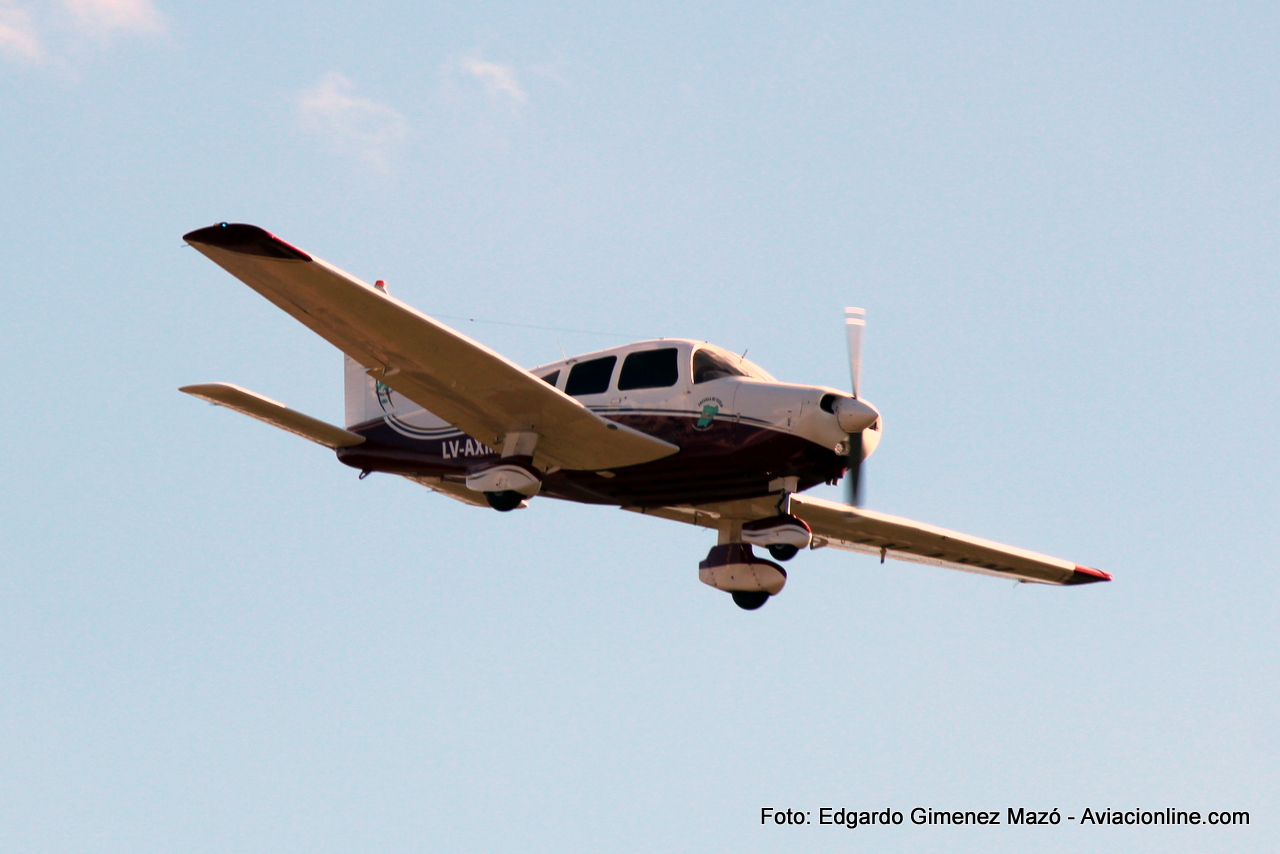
627, 495, 1111, 584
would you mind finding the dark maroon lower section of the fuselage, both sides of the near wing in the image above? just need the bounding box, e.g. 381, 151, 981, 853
338, 414, 845, 507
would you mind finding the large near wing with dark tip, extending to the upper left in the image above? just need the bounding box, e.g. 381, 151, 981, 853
184, 223, 680, 470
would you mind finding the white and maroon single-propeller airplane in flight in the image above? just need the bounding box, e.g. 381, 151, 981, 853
179, 223, 1111, 611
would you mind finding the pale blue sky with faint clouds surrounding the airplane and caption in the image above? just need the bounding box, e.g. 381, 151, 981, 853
0, 0, 1280, 854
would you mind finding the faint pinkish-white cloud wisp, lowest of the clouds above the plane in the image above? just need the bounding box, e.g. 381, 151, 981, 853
298, 72, 408, 170
